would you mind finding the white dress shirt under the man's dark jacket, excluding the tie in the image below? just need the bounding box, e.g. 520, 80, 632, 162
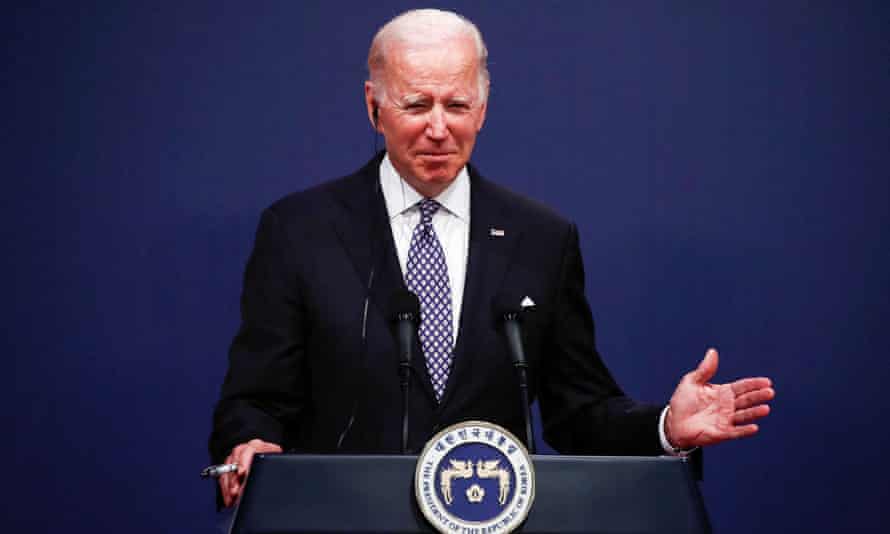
380, 154, 470, 344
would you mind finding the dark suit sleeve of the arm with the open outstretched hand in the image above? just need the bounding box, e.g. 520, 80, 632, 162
539, 224, 663, 455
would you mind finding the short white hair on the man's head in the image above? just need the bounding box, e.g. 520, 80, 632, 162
368, 9, 490, 102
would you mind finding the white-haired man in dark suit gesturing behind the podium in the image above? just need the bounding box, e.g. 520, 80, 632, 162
210, 10, 774, 505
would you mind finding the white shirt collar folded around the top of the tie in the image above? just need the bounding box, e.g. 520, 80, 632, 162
380, 154, 470, 221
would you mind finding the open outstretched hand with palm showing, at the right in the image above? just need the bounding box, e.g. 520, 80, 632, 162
665, 349, 776, 449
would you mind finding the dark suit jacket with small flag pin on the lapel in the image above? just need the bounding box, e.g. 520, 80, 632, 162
210, 155, 661, 461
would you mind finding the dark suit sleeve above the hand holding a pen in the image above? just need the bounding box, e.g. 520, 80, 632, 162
209, 208, 305, 462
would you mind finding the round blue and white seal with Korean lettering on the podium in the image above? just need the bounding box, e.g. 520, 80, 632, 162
414, 421, 535, 534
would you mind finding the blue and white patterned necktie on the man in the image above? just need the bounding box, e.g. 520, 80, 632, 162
405, 198, 454, 400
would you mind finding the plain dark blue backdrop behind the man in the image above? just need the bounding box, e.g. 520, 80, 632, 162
0, 1, 890, 533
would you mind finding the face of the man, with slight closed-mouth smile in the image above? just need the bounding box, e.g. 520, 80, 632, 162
365, 38, 485, 197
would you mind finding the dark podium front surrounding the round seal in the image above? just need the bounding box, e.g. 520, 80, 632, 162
231, 454, 711, 534
